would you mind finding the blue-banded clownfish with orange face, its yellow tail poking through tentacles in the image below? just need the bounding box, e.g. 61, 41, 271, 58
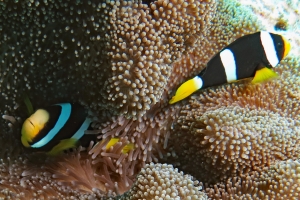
21, 101, 133, 155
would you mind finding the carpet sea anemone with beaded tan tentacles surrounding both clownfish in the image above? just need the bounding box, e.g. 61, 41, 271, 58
0, 0, 300, 199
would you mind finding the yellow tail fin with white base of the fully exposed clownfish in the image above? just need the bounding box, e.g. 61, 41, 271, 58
169, 76, 202, 104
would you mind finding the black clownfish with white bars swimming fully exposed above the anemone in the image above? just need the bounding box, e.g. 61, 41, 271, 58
169, 31, 291, 104
